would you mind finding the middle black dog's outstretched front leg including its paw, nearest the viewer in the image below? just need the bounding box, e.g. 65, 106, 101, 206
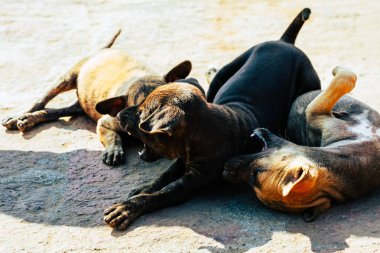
104, 170, 215, 230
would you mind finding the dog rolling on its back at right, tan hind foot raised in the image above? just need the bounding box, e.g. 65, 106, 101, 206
223, 67, 380, 221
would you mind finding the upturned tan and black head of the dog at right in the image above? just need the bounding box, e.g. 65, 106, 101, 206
223, 129, 329, 221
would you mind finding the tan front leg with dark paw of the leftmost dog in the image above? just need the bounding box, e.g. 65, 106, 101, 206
96, 115, 125, 166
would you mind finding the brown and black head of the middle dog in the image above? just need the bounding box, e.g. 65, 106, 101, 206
117, 82, 207, 162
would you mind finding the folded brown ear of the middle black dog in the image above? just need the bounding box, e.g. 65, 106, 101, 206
139, 106, 185, 136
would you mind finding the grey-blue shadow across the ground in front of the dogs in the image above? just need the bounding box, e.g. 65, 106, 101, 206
0, 147, 380, 252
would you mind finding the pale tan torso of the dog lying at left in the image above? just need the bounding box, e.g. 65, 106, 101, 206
77, 49, 148, 121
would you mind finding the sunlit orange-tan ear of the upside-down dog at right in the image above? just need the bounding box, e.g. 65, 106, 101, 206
281, 165, 318, 197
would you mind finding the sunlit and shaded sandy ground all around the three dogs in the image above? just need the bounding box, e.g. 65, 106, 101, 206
0, 0, 380, 252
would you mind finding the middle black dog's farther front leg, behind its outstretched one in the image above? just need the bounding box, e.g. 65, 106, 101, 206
128, 158, 185, 198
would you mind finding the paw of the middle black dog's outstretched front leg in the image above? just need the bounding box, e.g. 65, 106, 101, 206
104, 201, 139, 230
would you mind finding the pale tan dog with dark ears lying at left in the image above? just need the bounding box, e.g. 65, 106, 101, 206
2, 30, 192, 165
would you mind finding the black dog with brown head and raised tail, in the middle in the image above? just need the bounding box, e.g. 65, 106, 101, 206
104, 9, 320, 230
